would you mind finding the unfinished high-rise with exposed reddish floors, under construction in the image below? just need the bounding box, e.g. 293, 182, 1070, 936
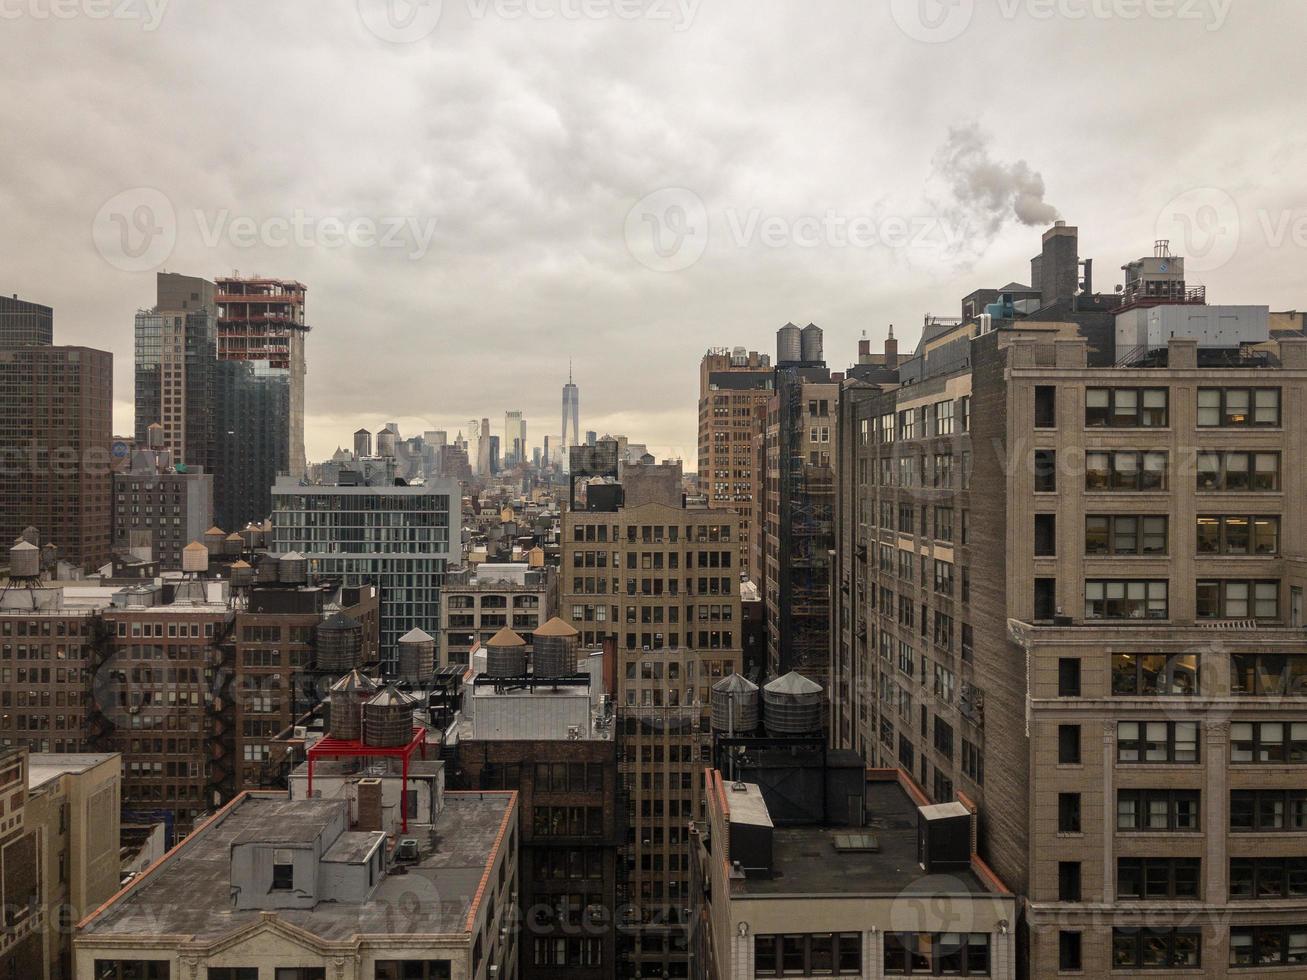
214, 276, 310, 477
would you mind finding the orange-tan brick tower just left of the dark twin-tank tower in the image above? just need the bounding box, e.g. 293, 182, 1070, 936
699, 348, 775, 574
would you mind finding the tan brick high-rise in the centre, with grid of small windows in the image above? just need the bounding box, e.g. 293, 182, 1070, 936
559, 463, 742, 977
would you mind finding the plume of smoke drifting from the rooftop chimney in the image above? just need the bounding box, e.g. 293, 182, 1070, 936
932, 123, 1057, 247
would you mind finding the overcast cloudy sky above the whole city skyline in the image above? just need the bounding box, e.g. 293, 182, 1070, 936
0, 0, 1307, 460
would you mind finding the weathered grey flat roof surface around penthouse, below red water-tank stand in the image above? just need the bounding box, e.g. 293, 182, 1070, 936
81, 793, 512, 941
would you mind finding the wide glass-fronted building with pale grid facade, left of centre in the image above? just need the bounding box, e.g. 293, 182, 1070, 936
272, 464, 463, 674
